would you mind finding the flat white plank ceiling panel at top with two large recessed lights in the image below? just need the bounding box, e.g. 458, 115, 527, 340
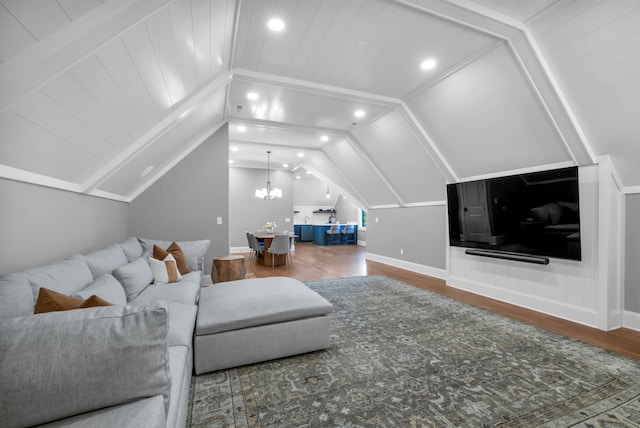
234, 0, 496, 97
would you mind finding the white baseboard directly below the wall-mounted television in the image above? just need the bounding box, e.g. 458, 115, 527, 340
447, 276, 599, 328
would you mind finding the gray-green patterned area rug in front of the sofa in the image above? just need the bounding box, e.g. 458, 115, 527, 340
187, 276, 640, 428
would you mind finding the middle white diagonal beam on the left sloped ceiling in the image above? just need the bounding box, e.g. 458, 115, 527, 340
82, 73, 231, 193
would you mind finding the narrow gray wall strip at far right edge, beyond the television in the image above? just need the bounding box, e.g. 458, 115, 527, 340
624, 194, 640, 313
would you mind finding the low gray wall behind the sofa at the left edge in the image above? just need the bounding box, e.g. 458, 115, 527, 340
0, 179, 127, 275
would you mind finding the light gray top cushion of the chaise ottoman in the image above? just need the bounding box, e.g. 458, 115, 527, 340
196, 277, 333, 336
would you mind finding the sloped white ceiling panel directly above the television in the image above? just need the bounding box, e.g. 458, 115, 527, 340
408, 42, 572, 178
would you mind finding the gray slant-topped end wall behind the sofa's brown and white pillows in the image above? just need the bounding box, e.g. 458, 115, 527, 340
129, 125, 229, 272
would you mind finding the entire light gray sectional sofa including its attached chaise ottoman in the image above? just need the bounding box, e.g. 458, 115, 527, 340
0, 238, 333, 428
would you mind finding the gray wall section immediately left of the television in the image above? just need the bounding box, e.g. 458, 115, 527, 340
358, 205, 447, 269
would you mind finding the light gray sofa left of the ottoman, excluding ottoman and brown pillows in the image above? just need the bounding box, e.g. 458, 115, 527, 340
0, 238, 210, 427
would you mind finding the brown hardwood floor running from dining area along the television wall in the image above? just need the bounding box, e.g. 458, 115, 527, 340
239, 242, 640, 359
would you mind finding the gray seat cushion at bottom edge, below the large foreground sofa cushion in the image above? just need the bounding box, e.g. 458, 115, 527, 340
38, 395, 167, 428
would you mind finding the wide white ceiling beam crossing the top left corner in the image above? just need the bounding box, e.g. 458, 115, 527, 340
0, 0, 173, 111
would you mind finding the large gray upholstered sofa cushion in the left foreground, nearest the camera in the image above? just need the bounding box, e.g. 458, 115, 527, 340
0, 302, 171, 427
